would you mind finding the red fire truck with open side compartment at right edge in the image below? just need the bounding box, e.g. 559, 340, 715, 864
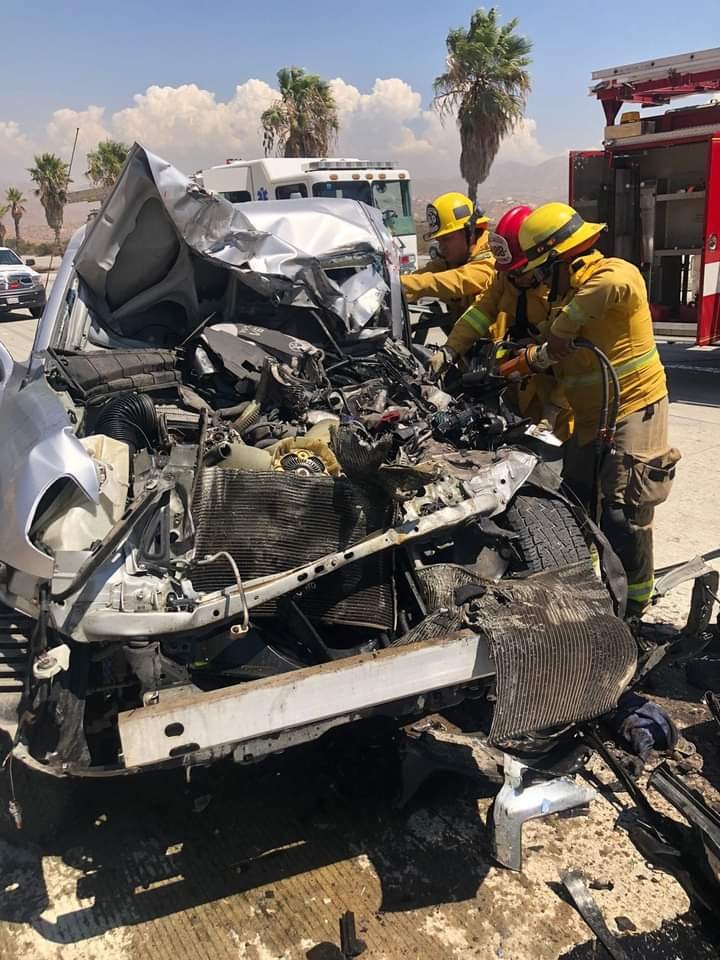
570, 48, 720, 345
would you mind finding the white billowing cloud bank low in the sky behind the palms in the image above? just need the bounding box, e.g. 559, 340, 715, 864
0, 77, 546, 183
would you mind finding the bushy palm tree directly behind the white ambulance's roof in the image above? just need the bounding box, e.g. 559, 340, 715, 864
260, 67, 339, 157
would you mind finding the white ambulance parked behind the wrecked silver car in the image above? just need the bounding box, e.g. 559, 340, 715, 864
196, 157, 417, 273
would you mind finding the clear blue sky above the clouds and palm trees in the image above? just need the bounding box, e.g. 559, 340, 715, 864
0, 0, 720, 178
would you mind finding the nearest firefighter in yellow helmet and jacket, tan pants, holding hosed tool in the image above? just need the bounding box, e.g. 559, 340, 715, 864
520, 203, 680, 619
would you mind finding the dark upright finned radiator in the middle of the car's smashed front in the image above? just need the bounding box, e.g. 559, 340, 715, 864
192, 467, 395, 630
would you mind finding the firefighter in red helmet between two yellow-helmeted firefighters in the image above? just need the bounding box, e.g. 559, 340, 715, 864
430, 206, 572, 440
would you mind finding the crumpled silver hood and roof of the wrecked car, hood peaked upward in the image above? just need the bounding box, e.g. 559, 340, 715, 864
75, 144, 402, 346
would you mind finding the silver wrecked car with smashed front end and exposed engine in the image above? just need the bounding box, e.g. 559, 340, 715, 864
0, 146, 636, 800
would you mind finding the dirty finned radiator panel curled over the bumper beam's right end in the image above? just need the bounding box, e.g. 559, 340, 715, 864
406, 563, 637, 744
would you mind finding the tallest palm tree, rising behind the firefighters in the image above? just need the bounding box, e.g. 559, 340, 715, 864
434, 7, 532, 200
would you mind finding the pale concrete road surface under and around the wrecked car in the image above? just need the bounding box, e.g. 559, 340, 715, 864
0, 294, 720, 960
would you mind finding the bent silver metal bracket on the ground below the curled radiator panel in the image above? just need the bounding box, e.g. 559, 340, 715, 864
493, 753, 596, 871
